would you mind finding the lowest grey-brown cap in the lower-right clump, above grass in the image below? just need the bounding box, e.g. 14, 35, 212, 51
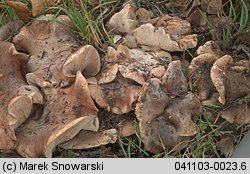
140, 115, 182, 153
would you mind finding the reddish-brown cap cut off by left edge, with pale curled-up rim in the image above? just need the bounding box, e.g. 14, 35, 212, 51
0, 42, 43, 150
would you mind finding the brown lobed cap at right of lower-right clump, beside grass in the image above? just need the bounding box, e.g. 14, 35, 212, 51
164, 93, 202, 136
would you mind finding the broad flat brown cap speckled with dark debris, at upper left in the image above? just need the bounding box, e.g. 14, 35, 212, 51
13, 15, 80, 73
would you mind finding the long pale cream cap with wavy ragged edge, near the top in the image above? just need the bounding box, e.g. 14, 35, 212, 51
134, 23, 197, 52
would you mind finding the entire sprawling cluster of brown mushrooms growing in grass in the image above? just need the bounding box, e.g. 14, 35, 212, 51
0, 4, 250, 157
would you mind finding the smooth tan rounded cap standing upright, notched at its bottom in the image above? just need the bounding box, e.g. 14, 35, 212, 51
63, 45, 101, 77
